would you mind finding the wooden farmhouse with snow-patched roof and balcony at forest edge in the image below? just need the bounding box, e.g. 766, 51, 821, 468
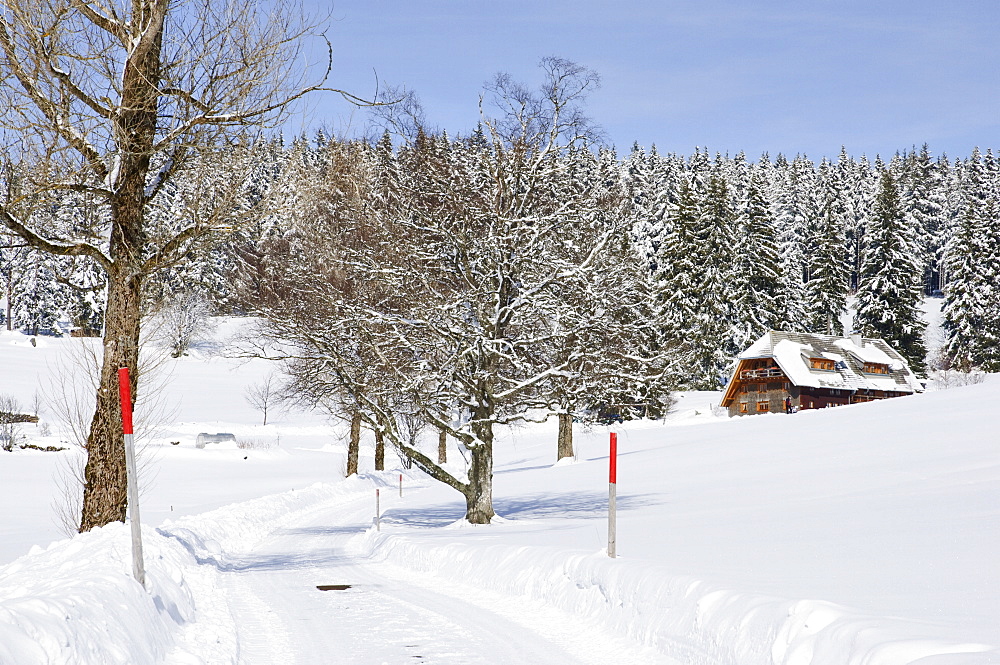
721, 331, 923, 416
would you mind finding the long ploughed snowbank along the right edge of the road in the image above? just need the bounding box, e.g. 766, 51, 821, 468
353, 526, 1000, 665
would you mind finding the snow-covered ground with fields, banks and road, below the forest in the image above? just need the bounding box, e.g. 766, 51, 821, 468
0, 322, 1000, 665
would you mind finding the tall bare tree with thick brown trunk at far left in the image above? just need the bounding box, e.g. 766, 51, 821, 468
0, 0, 360, 531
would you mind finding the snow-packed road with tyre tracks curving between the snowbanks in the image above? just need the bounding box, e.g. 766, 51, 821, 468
196, 488, 676, 665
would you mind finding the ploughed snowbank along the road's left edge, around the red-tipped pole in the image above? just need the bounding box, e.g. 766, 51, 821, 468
0, 478, 371, 665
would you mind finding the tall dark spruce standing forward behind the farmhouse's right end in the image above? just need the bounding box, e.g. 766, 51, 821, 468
854, 169, 927, 374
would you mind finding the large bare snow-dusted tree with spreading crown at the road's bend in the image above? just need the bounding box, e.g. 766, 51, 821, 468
250, 59, 672, 523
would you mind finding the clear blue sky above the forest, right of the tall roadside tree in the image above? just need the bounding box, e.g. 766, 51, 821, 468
296, 0, 1000, 159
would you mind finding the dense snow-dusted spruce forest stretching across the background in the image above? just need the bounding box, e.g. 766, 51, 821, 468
0, 136, 1000, 389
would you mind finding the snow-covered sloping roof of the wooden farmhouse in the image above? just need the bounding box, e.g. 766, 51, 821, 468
727, 331, 921, 400
